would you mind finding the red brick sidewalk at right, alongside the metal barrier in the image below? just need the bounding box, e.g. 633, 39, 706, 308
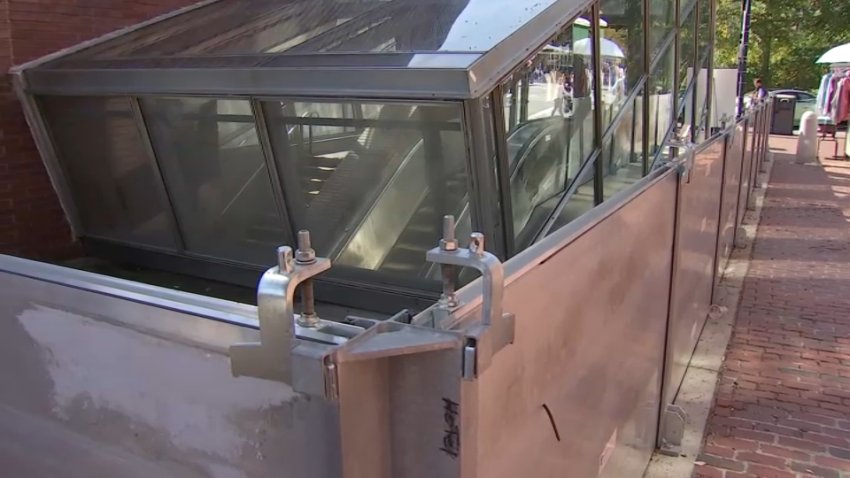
696, 138, 850, 478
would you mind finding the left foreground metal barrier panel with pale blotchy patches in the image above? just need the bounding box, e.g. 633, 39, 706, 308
0, 256, 339, 478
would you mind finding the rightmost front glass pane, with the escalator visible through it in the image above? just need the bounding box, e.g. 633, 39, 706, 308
264, 100, 472, 280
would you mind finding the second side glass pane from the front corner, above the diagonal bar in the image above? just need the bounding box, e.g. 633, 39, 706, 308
600, 0, 644, 127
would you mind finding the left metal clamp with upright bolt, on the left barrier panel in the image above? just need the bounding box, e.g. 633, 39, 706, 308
230, 231, 331, 384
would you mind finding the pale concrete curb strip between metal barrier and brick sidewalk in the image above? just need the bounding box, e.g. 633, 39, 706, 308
644, 152, 774, 478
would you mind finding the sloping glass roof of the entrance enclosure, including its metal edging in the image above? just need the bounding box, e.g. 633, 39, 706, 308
26, 0, 586, 98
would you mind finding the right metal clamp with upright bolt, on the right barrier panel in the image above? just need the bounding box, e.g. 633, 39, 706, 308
426, 216, 515, 379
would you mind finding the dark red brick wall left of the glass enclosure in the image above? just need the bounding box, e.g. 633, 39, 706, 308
0, 0, 196, 259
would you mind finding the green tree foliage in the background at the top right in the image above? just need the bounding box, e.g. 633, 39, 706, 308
715, 0, 850, 89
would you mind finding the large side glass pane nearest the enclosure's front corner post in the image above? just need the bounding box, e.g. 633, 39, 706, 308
504, 14, 594, 250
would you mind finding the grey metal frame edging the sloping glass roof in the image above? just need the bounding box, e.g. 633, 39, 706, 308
18, 0, 584, 99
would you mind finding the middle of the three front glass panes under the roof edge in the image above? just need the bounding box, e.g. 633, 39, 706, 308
142, 98, 289, 265
